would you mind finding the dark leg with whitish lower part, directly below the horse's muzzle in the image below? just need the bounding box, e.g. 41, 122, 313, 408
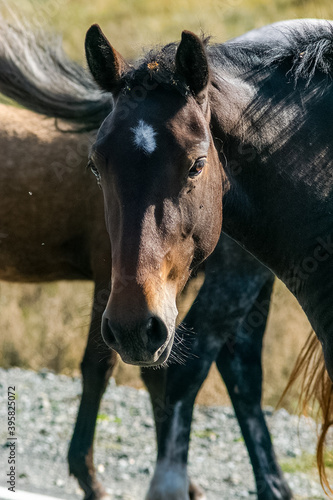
142, 335, 218, 500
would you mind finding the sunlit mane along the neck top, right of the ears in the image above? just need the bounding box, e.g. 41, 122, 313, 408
211, 20, 333, 86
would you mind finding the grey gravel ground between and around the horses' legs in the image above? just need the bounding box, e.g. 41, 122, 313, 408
0, 368, 327, 500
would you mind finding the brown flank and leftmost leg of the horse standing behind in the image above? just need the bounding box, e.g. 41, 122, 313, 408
0, 101, 116, 498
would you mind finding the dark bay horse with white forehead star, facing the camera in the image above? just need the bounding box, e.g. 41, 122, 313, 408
86, 20, 333, 498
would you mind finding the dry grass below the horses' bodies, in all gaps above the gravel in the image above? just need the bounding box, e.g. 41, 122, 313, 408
0, 281, 310, 411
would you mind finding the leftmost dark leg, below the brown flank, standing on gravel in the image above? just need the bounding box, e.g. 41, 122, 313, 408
68, 288, 117, 500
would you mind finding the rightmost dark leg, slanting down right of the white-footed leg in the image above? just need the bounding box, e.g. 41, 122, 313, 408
216, 279, 292, 500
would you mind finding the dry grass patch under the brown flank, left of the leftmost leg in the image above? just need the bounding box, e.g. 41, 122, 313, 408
0, 282, 92, 374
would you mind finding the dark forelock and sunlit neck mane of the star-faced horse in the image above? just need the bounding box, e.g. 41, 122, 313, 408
117, 20, 333, 101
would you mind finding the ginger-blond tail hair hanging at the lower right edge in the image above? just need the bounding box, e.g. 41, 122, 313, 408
278, 331, 333, 494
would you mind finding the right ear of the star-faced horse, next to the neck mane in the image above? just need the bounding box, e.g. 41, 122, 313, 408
176, 31, 209, 96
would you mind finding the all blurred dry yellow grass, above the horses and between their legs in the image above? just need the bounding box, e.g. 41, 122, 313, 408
0, 0, 333, 409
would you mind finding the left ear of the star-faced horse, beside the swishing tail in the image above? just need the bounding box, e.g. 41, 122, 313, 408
85, 24, 129, 92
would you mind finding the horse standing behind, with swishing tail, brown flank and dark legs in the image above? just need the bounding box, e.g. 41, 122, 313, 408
0, 17, 291, 500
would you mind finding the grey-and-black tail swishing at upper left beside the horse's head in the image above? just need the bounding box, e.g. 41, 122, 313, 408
0, 16, 112, 130
